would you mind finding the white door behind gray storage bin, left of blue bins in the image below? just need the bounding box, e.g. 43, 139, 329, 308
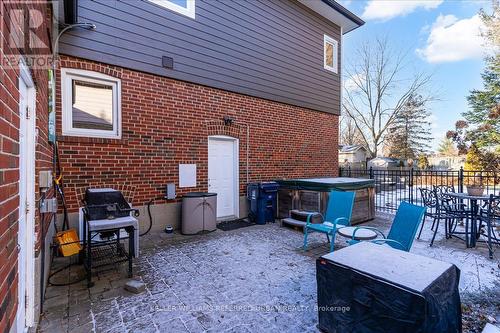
208, 136, 239, 218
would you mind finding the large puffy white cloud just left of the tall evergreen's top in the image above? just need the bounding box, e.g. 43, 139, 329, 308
417, 15, 484, 63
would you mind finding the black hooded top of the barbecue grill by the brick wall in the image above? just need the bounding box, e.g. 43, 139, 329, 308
85, 188, 130, 220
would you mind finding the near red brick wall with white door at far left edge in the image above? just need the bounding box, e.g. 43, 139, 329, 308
0, 1, 52, 333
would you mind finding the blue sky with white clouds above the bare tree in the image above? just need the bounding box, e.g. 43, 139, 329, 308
339, 0, 491, 149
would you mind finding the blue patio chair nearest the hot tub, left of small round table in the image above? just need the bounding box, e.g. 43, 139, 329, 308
304, 191, 356, 252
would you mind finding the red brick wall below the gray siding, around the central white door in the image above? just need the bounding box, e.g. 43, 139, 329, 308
57, 56, 338, 211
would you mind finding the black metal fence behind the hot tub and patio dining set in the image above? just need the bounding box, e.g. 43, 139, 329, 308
339, 167, 500, 211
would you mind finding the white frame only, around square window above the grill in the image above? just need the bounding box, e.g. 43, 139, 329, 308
61, 68, 122, 139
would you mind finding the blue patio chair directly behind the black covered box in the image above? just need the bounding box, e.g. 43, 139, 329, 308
348, 201, 426, 252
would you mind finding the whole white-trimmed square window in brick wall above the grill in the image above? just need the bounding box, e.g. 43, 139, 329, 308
61, 68, 121, 139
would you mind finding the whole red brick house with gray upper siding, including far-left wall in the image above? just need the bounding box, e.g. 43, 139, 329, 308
0, 0, 363, 332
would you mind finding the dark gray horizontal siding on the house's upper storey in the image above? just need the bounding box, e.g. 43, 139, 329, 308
60, 0, 341, 114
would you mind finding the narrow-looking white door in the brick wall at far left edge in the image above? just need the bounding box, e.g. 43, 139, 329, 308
16, 61, 36, 332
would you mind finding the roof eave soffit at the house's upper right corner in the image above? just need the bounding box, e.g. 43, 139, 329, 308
297, 0, 365, 34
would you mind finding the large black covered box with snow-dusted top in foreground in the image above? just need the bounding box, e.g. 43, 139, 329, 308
316, 242, 462, 333
